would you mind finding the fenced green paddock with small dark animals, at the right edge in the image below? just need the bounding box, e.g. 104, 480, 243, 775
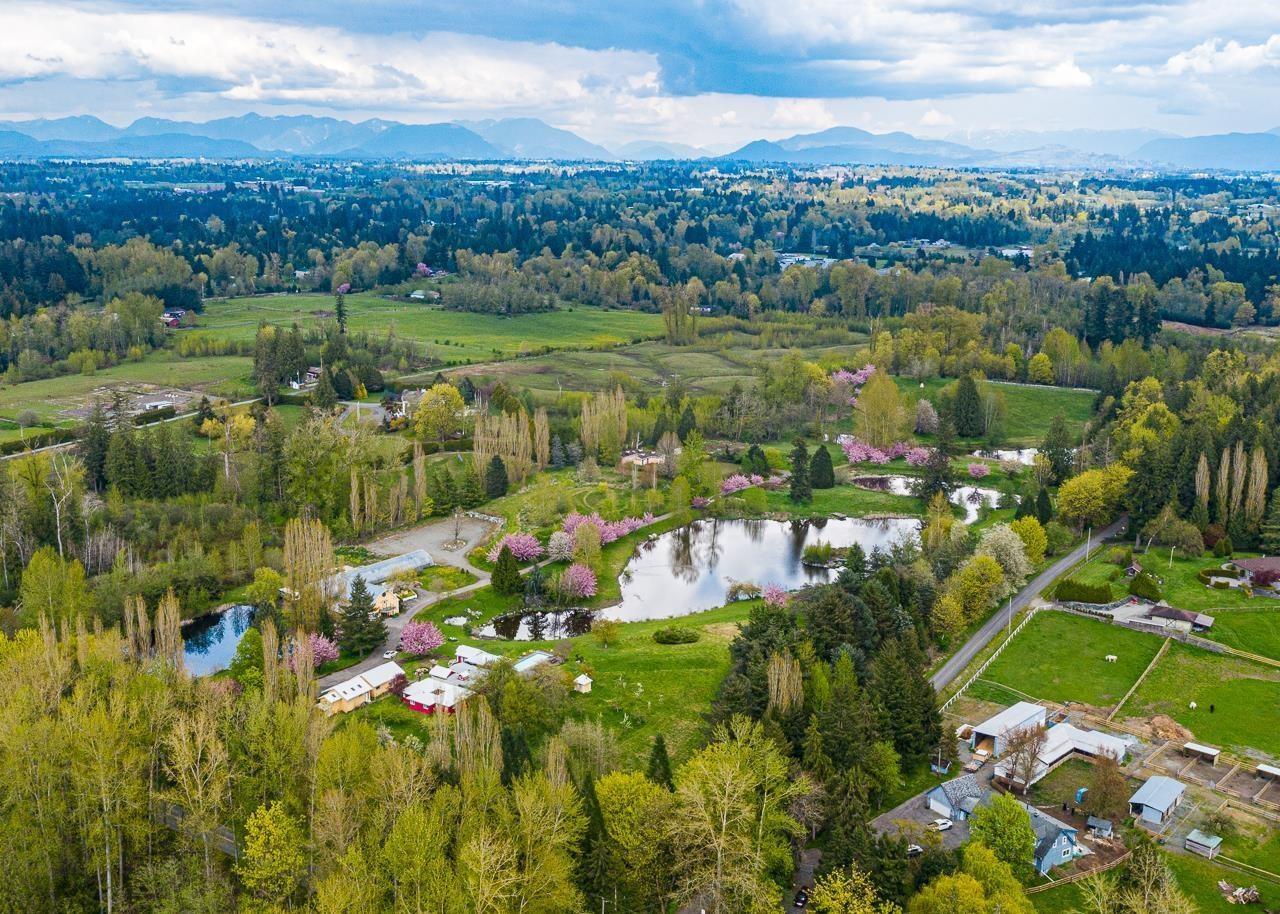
1123, 641, 1280, 758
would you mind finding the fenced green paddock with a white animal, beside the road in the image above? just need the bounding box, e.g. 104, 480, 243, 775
983, 609, 1161, 708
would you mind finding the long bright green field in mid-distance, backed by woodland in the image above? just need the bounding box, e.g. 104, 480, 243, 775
197, 292, 663, 364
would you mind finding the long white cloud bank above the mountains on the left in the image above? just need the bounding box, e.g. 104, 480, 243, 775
0, 3, 658, 111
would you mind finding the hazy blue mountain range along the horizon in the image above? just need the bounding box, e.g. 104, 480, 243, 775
0, 114, 1280, 170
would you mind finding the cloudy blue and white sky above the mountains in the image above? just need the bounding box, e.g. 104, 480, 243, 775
0, 0, 1280, 151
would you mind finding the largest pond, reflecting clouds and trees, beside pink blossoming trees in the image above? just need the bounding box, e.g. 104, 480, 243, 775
475, 517, 919, 641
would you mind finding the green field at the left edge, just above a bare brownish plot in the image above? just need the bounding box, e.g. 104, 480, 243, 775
0, 352, 253, 422
